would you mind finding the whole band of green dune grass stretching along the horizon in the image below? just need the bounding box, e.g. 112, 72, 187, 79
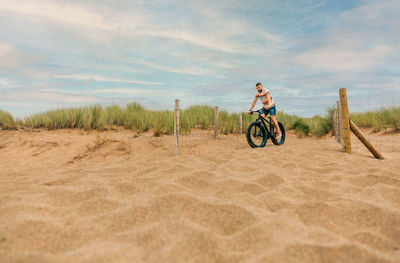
0, 103, 400, 137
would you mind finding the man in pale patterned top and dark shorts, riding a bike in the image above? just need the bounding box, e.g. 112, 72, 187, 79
248, 82, 282, 140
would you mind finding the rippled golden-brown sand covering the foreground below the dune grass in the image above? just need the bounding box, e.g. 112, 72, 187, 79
0, 130, 400, 262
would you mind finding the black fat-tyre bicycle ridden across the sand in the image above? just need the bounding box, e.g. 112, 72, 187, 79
246, 110, 286, 148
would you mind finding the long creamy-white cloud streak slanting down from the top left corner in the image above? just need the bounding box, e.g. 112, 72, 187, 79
0, 0, 283, 54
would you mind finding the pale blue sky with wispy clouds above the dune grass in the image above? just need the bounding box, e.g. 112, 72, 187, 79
0, 0, 400, 118
